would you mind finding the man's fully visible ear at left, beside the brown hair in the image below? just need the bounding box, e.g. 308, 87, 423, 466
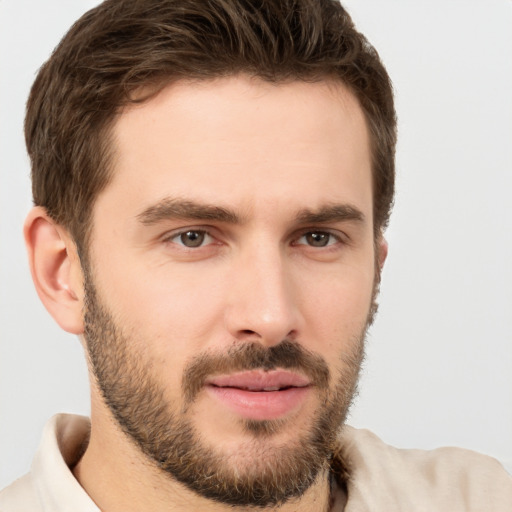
24, 206, 84, 334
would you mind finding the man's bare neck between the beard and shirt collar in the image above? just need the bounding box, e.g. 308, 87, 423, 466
73, 406, 343, 512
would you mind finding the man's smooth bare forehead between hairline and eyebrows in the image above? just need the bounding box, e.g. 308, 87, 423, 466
98, 76, 371, 222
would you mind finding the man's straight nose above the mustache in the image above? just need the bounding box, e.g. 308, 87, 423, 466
225, 244, 301, 346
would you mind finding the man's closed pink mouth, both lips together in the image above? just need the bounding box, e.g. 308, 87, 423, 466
205, 370, 312, 421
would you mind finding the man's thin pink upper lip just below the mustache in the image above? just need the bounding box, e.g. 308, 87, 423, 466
205, 370, 311, 391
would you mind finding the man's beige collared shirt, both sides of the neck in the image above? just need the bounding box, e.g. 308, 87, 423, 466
0, 414, 512, 512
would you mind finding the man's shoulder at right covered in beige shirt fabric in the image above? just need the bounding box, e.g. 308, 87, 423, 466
336, 427, 512, 512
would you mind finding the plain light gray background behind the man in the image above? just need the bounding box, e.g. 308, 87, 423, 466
0, 0, 512, 487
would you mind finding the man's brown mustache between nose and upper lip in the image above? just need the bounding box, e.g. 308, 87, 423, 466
182, 340, 330, 405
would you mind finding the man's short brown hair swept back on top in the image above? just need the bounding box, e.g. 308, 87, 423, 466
25, 0, 396, 254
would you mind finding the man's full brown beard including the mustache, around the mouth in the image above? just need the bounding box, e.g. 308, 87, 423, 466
84, 272, 368, 507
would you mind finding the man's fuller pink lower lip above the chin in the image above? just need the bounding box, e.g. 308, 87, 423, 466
206, 386, 310, 421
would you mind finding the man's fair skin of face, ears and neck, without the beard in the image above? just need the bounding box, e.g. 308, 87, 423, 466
25, 76, 387, 512
